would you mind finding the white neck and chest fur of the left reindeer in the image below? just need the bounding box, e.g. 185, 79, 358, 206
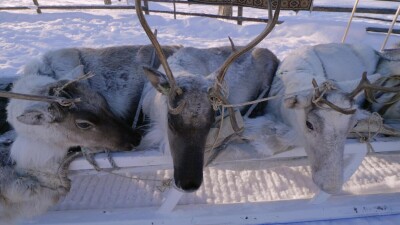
0, 72, 74, 222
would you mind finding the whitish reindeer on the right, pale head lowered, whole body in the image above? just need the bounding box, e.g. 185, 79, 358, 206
244, 43, 400, 193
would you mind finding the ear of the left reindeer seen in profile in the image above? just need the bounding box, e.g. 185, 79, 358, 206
17, 103, 61, 125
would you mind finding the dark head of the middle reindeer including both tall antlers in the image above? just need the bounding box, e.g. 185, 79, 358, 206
135, 0, 280, 192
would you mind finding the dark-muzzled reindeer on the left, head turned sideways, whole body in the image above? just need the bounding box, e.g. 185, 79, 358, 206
0, 46, 179, 219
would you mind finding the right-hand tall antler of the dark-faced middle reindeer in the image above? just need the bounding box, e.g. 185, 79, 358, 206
216, 0, 281, 83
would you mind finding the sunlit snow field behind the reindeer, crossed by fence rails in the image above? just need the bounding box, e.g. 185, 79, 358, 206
0, 0, 400, 76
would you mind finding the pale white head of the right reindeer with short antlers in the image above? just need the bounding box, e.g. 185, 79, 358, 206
284, 73, 400, 193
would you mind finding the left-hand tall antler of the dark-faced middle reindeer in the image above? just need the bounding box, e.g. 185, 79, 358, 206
135, 0, 182, 94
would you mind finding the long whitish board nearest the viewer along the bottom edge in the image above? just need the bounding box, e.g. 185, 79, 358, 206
21, 193, 400, 225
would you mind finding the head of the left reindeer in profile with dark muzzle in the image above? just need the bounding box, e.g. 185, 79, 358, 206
8, 66, 141, 150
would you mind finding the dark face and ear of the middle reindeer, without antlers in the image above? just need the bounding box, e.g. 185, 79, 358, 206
145, 68, 215, 191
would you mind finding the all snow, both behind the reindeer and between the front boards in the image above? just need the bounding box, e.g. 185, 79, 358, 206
0, 0, 400, 224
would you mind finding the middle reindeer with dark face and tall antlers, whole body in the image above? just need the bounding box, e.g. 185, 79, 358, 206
136, 0, 279, 192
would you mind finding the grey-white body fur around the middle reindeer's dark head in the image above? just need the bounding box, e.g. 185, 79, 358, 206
139, 47, 277, 152
